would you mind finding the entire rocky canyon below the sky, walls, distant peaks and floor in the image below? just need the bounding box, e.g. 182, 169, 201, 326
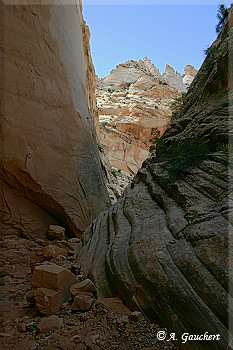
0, 0, 233, 350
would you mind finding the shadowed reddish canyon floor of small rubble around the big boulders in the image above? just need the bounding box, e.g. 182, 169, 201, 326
0, 236, 177, 350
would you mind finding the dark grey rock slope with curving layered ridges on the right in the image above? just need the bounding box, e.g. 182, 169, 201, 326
79, 8, 233, 350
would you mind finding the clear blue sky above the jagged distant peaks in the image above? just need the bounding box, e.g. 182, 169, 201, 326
83, 0, 231, 78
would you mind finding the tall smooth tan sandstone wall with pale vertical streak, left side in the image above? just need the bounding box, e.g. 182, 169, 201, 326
0, 1, 109, 237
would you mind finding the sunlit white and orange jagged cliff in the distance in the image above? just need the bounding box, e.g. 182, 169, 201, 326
96, 57, 197, 174
